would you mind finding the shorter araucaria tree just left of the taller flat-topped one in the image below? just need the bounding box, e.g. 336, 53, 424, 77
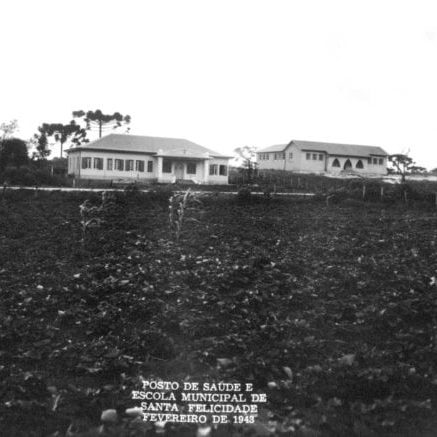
36, 120, 88, 158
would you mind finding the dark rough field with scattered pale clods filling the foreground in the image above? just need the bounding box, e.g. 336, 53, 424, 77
0, 192, 437, 437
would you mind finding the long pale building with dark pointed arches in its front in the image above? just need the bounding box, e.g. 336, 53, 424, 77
257, 140, 388, 176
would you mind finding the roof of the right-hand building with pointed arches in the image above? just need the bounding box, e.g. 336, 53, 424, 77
258, 140, 388, 157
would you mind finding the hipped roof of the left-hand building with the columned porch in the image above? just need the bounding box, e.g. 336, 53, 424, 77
67, 134, 229, 158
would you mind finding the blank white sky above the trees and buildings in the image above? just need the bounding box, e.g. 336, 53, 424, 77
0, 0, 437, 169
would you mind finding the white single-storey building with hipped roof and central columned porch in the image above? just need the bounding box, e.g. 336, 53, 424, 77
67, 134, 231, 184
